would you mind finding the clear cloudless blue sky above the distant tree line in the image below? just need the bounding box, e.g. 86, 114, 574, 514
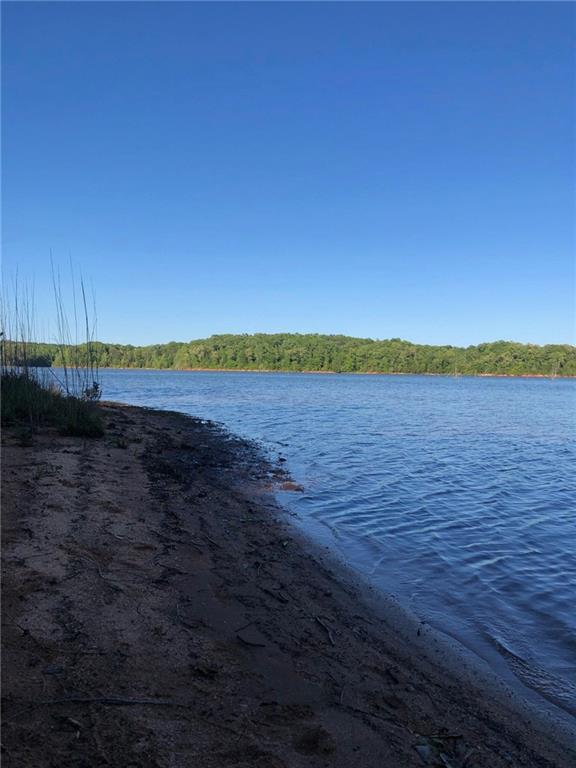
2, 2, 576, 344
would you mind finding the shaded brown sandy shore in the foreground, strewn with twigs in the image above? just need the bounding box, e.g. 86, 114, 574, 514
3, 404, 576, 768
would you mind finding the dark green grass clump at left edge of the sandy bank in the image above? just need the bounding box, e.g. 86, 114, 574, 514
0, 369, 104, 437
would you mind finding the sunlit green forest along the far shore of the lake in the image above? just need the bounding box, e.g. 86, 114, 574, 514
9, 333, 576, 376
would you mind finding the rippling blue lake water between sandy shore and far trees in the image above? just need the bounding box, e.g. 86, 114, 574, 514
97, 371, 576, 713
